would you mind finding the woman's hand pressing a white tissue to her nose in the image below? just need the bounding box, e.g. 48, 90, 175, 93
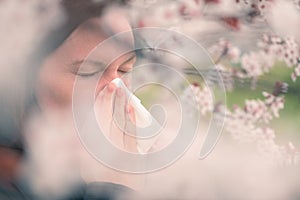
95, 83, 137, 153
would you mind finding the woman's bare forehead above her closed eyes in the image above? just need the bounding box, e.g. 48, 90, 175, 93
59, 11, 134, 65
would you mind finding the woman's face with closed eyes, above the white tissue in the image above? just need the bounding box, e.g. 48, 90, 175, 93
37, 12, 136, 111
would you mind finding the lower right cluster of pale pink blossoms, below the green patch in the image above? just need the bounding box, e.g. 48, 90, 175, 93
225, 92, 298, 164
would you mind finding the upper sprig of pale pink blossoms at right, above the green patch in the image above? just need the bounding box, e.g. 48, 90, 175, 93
209, 34, 300, 81
